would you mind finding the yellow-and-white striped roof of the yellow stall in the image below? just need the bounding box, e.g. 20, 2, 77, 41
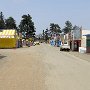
0, 29, 16, 38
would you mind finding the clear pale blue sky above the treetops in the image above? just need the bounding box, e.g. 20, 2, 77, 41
0, 0, 90, 34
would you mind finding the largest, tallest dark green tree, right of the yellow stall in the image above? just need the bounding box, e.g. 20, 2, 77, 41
19, 14, 36, 38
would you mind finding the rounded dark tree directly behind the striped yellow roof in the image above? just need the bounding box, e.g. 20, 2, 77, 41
5, 17, 17, 29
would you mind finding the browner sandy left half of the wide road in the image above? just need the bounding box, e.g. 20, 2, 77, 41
0, 47, 44, 90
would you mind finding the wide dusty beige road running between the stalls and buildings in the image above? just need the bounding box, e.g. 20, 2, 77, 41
0, 44, 90, 90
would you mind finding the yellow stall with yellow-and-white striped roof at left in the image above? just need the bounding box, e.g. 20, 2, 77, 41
0, 29, 18, 48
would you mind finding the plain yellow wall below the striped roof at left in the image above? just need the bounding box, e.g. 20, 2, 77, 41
0, 38, 16, 48
